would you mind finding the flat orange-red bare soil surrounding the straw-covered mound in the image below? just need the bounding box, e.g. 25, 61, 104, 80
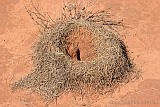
0, 0, 160, 107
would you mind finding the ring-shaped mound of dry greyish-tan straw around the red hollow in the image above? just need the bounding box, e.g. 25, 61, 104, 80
12, 2, 138, 100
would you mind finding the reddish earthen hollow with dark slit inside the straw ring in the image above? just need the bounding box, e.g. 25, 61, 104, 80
67, 28, 97, 61
